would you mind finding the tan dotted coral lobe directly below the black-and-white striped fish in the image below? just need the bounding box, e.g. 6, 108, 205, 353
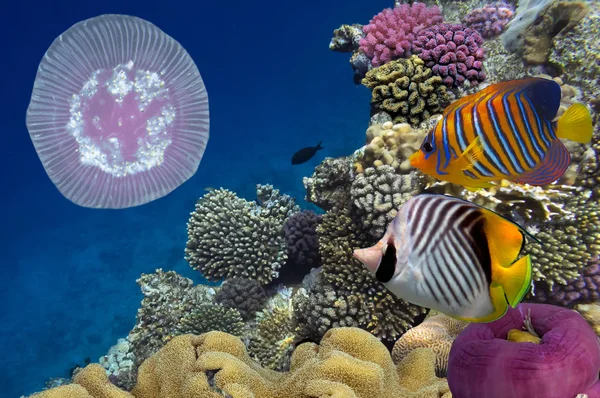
392, 314, 469, 377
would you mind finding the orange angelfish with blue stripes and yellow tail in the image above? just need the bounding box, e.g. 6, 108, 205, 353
410, 78, 592, 189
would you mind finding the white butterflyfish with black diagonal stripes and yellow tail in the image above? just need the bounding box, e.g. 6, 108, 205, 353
354, 194, 535, 322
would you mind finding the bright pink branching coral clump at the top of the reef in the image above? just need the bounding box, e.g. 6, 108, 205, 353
360, 3, 443, 66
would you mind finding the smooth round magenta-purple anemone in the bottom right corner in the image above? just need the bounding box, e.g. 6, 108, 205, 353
448, 304, 600, 398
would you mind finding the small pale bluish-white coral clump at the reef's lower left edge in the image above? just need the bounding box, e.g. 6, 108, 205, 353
98, 339, 136, 391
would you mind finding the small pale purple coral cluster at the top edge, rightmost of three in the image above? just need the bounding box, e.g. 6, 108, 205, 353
463, 1, 515, 38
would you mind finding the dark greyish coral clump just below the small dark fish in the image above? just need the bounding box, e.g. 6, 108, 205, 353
302, 157, 352, 210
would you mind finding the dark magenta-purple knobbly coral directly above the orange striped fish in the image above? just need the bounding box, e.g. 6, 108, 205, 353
413, 24, 486, 87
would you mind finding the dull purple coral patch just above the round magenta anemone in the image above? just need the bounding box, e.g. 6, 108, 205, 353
533, 260, 600, 307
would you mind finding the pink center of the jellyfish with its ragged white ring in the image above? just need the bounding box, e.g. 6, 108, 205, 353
67, 61, 176, 177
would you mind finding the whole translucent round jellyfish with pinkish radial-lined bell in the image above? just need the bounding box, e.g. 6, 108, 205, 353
26, 15, 209, 209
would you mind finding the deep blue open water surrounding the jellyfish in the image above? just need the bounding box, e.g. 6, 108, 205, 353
0, 0, 392, 397
